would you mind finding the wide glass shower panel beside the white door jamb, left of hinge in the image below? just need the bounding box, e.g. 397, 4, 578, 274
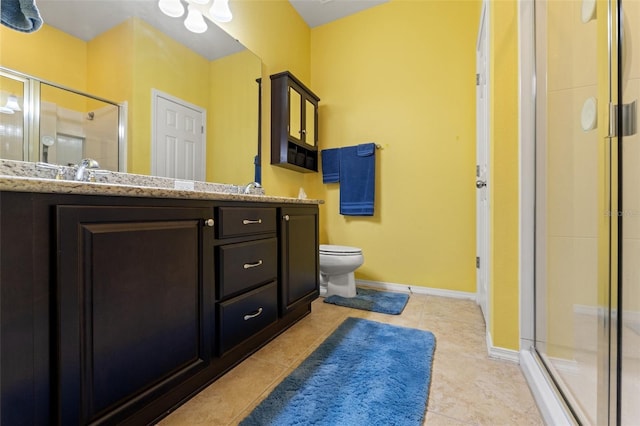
535, 0, 612, 424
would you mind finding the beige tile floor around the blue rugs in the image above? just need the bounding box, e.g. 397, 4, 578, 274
160, 294, 543, 426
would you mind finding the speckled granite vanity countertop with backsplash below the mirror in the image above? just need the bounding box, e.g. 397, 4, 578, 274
0, 160, 323, 204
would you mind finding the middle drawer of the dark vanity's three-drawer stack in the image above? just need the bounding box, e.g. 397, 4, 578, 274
217, 238, 278, 299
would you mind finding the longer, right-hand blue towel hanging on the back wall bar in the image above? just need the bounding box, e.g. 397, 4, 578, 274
340, 143, 376, 216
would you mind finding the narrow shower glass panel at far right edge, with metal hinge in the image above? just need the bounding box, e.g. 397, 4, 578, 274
613, 0, 640, 425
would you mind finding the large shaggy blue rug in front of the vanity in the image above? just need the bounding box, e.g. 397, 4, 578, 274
240, 318, 435, 426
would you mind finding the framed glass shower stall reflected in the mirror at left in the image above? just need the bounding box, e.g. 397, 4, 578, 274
0, 67, 127, 171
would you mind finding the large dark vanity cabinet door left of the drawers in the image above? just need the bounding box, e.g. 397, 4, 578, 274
56, 206, 215, 425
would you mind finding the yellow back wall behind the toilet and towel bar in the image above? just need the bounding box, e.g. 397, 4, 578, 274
311, 1, 480, 292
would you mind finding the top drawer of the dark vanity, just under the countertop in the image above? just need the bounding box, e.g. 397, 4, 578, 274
217, 207, 276, 238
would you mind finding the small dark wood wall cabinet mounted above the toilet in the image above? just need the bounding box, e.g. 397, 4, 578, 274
271, 71, 320, 172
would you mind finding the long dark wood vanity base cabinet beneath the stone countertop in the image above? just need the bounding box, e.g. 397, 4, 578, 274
0, 192, 318, 426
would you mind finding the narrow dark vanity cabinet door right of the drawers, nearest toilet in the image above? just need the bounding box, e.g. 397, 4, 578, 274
280, 206, 319, 315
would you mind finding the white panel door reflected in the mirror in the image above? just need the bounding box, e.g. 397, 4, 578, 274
151, 90, 206, 181
